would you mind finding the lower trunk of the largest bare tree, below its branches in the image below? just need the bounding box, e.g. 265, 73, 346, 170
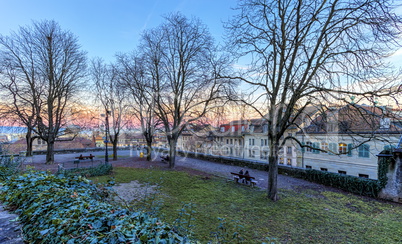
268, 143, 279, 201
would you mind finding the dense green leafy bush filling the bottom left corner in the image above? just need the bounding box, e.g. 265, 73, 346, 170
0, 172, 190, 243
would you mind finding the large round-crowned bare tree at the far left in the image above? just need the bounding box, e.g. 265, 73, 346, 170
0, 20, 86, 163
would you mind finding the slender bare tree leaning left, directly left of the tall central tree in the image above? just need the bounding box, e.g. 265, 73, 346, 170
116, 53, 160, 161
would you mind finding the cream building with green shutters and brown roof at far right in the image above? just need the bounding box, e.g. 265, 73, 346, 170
297, 105, 402, 179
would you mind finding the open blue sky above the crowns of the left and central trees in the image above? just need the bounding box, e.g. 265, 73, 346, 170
0, 0, 237, 62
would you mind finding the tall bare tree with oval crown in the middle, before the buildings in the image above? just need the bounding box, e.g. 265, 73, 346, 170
141, 14, 231, 168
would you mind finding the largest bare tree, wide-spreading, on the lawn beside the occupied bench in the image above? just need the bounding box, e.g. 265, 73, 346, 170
226, 0, 401, 201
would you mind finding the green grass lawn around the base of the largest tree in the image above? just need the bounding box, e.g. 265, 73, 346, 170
92, 168, 402, 243
